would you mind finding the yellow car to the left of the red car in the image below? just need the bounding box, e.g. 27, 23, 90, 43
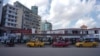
26, 40, 44, 47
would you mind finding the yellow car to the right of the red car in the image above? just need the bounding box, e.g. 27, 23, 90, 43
75, 41, 98, 47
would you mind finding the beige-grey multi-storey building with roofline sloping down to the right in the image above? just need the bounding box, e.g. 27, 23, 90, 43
14, 1, 41, 31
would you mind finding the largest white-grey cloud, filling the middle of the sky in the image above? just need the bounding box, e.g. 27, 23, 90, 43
49, 0, 95, 29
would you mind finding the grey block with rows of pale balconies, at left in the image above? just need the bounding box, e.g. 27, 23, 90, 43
2, 4, 17, 28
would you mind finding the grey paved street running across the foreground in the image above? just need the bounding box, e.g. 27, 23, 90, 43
0, 44, 100, 56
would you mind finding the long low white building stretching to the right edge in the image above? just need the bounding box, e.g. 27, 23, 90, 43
46, 25, 100, 40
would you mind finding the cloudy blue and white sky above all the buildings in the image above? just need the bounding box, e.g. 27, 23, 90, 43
4, 0, 100, 29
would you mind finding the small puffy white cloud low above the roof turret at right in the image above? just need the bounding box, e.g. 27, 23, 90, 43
73, 17, 96, 28
